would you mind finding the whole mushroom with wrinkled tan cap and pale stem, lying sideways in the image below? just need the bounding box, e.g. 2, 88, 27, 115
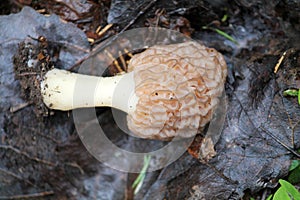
41, 42, 227, 140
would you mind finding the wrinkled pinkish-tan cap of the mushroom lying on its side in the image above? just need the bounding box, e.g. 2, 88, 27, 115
127, 41, 227, 140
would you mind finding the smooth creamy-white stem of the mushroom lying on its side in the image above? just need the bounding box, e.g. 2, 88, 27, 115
41, 69, 138, 113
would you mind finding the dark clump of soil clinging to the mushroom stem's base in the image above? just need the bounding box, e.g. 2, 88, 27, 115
13, 36, 54, 116
